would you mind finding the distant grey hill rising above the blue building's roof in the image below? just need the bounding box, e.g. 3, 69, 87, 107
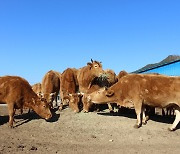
133, 55, 180, 73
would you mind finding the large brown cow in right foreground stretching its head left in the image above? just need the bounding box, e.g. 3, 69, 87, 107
88, 74, 180, 131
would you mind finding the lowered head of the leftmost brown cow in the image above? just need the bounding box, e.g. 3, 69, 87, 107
32, 98, 52, 120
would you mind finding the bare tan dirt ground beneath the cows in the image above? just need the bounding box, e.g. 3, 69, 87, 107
0, 106, 180, 154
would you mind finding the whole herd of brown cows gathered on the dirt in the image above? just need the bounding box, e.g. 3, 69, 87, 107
0, 60, 180, 131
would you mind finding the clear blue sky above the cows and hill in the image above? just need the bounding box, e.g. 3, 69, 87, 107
0, 0, 180, 84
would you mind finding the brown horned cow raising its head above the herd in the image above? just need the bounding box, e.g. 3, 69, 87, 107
77, 59, 103, 112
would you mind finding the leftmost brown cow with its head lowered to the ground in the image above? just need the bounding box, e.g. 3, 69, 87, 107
0, 76, 52, 128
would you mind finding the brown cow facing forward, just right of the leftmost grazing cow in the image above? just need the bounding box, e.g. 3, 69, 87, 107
41, 70, 61, 108
